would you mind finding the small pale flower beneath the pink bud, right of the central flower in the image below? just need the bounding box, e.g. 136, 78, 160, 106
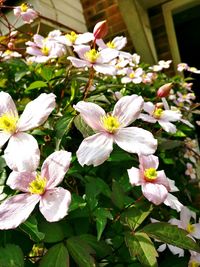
139, 102, 182, 133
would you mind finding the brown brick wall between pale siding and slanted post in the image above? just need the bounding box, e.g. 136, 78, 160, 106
81, 0, 135, 53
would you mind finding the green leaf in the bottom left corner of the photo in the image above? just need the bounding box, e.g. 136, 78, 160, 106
0, 244, 24, 267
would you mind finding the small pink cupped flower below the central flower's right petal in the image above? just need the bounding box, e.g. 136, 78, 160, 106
128, 155, 170, 205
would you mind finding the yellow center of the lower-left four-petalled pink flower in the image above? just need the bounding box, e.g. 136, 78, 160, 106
29, 174, 47, 195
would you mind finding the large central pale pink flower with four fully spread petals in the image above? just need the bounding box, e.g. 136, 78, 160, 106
74, 95, 157, 166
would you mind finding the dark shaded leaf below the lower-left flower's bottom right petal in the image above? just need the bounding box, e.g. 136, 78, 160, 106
39, 221, 65, 243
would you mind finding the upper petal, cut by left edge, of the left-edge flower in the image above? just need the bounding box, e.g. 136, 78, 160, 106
0, 91, 18, 117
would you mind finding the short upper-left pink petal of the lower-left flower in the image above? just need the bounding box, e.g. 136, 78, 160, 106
6, 171, 36, 192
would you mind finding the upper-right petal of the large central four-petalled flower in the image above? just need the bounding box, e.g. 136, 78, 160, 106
112, 95, 144, 127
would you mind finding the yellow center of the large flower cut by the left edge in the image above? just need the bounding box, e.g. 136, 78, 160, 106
0, 113, 18, 133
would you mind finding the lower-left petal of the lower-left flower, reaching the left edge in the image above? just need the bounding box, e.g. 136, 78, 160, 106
0, 193, 40, 230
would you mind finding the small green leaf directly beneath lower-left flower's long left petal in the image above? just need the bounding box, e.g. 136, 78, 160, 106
20, 216, 45, 242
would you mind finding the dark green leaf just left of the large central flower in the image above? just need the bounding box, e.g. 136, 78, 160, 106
55, 113, 74, 139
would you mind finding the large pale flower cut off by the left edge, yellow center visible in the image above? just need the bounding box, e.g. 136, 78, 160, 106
0, 92, 56, 171
